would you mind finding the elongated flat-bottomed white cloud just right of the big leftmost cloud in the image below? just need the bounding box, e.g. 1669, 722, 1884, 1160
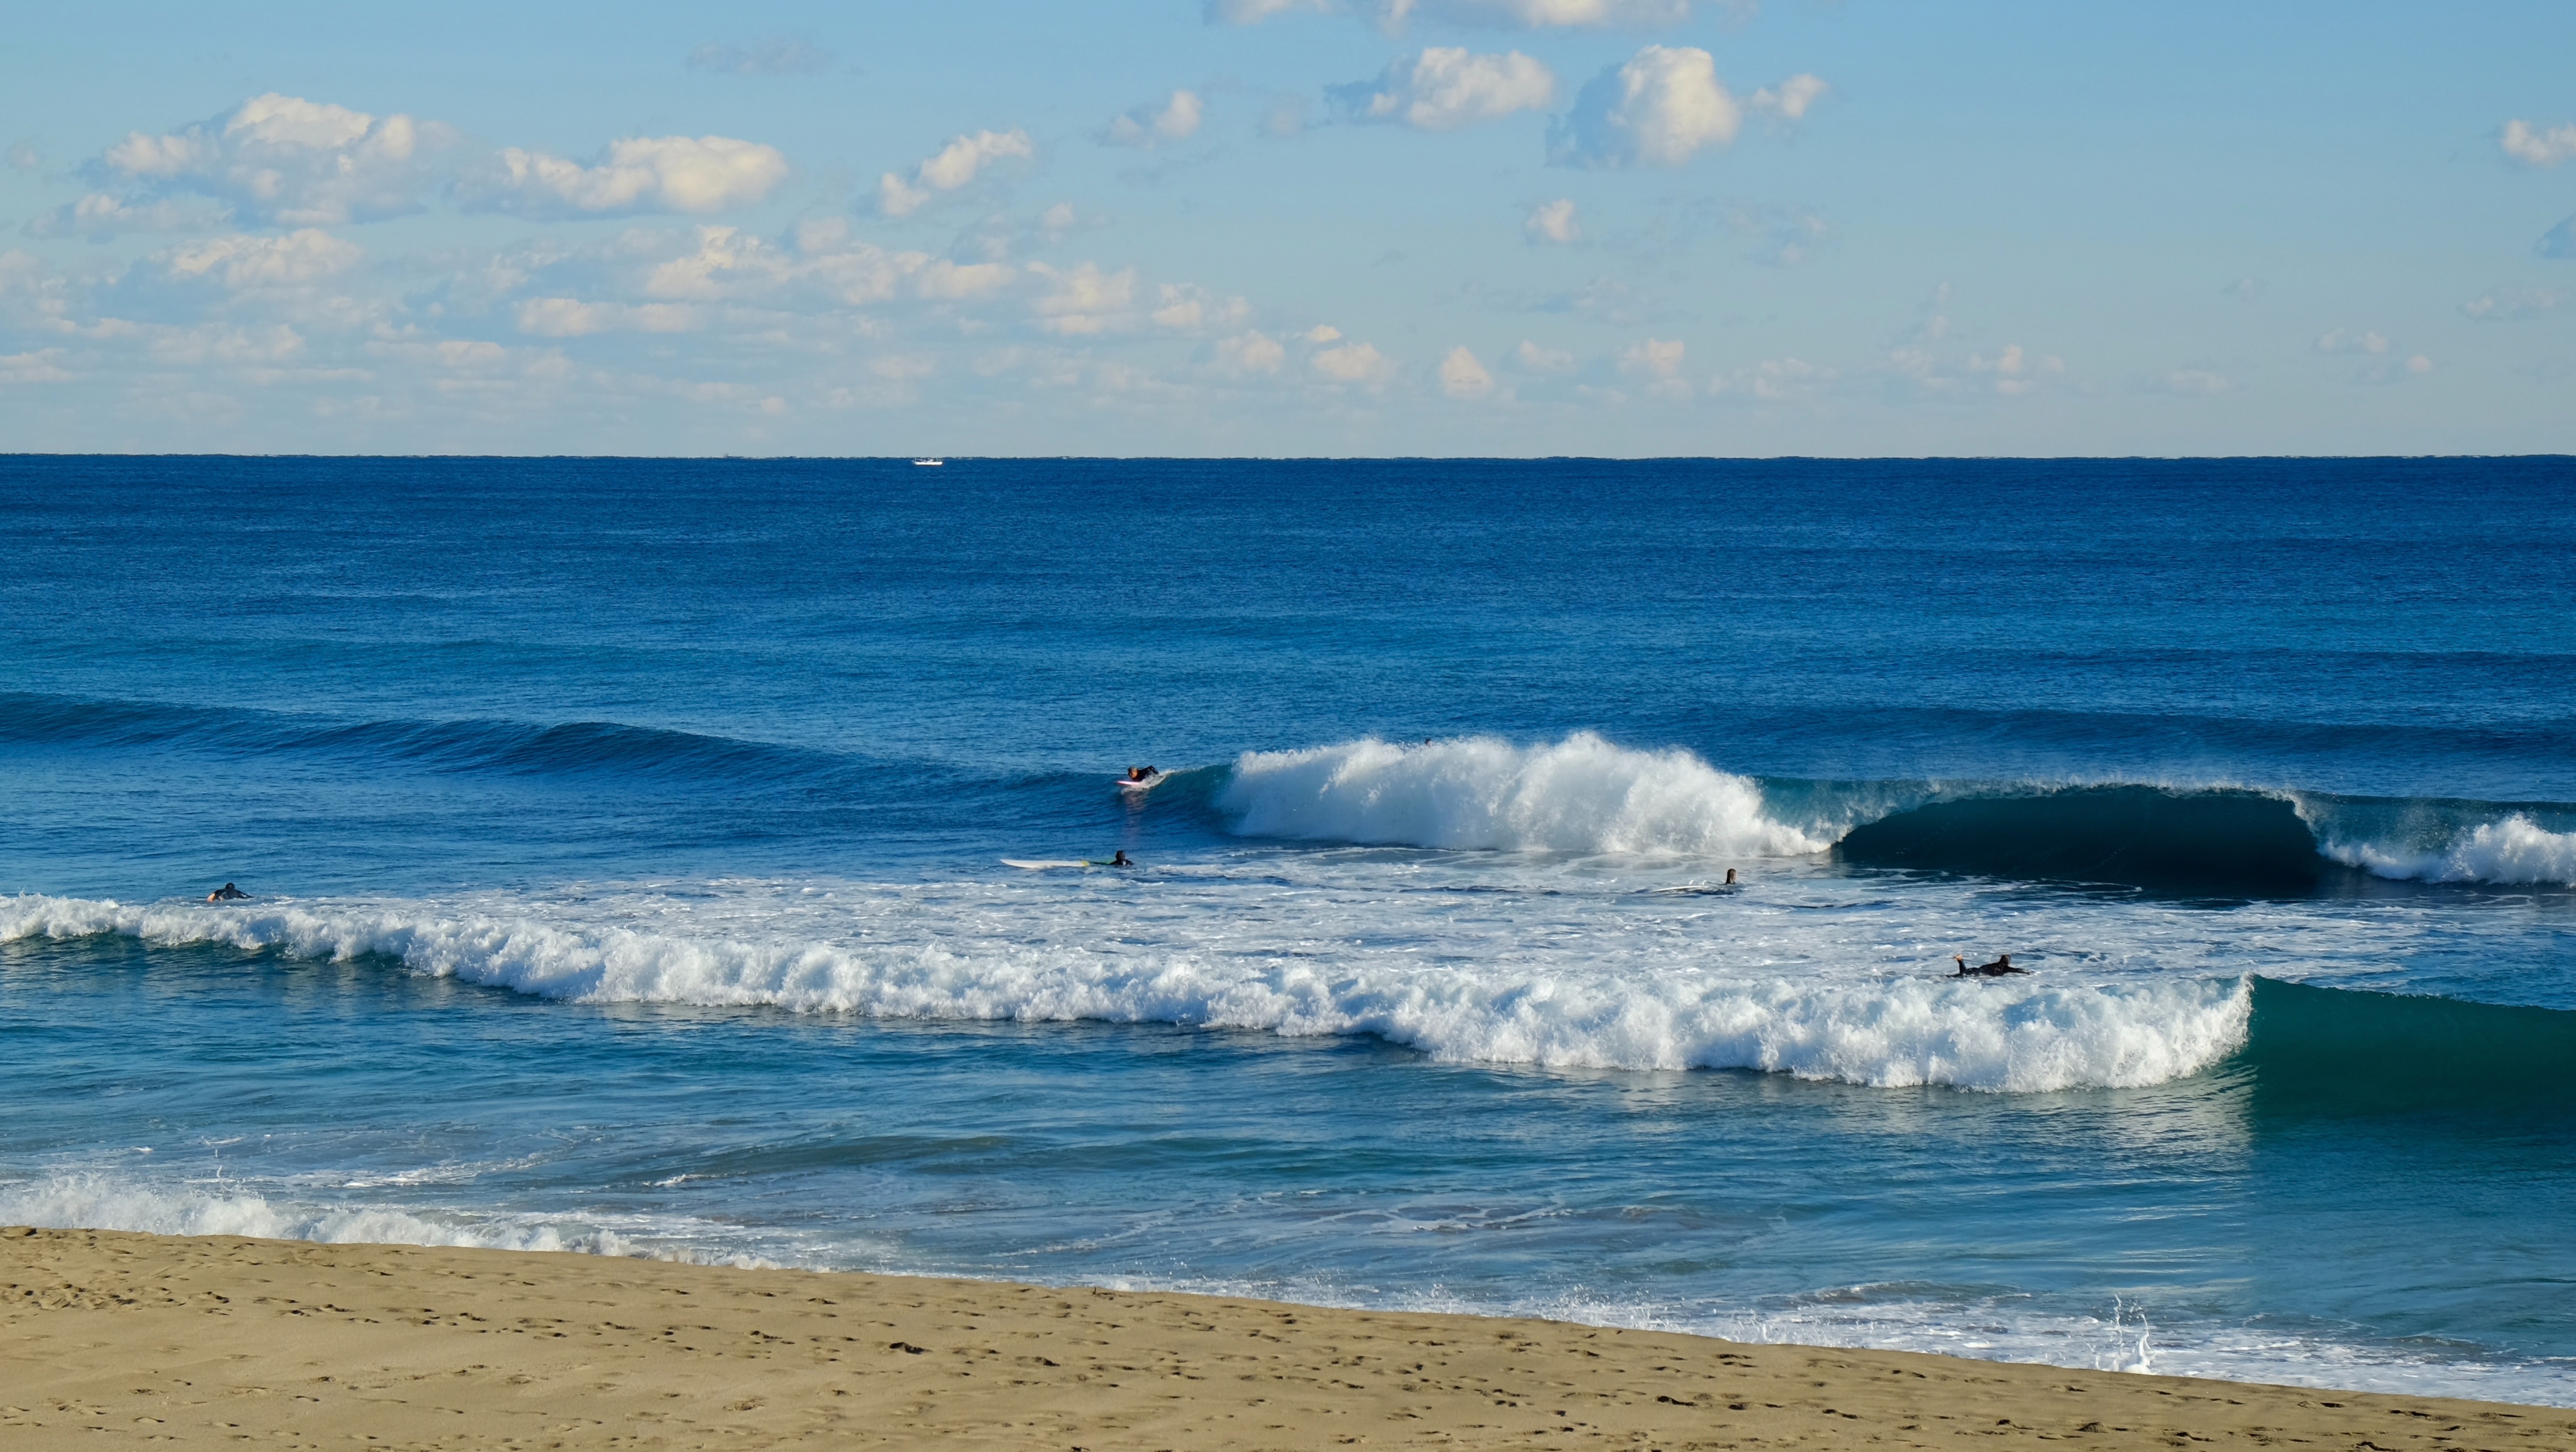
474, 136, 788, 216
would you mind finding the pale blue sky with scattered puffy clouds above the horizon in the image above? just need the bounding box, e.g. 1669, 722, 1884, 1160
0, 0, 2576, 456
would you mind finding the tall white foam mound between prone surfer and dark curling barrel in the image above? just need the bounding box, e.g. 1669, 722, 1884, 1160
1216, 731, 1827, 857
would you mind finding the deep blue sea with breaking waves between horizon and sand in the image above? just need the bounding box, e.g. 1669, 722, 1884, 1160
0, 458, 2576, 1406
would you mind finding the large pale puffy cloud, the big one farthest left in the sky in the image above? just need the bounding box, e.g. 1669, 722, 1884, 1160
88, 93, 453, 227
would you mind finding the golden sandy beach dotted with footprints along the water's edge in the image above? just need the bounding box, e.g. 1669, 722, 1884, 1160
0, 1228, 2576, 1452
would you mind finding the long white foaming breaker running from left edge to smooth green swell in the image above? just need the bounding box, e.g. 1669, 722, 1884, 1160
0, 896, 2251, 1092
